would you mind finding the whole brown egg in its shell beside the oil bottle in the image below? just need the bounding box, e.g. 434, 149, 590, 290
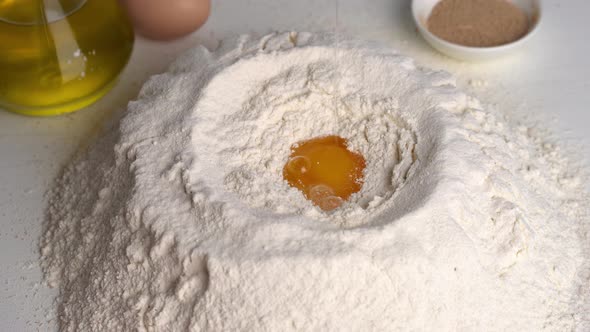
120, 0, 211, 40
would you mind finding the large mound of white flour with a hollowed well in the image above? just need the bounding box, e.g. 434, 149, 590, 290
41, 33, 590, 331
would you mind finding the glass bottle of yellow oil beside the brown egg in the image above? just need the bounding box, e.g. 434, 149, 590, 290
0, 0, 134, 116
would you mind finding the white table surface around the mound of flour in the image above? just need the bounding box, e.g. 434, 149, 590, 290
0, 0, 590, 331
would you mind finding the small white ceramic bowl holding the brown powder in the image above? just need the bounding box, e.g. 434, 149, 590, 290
412, 0, 541, 61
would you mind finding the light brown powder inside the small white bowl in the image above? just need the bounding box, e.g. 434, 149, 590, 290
428, 0, 529, 47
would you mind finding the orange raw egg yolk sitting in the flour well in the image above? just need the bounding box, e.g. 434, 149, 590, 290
283, 136, 365, 211
